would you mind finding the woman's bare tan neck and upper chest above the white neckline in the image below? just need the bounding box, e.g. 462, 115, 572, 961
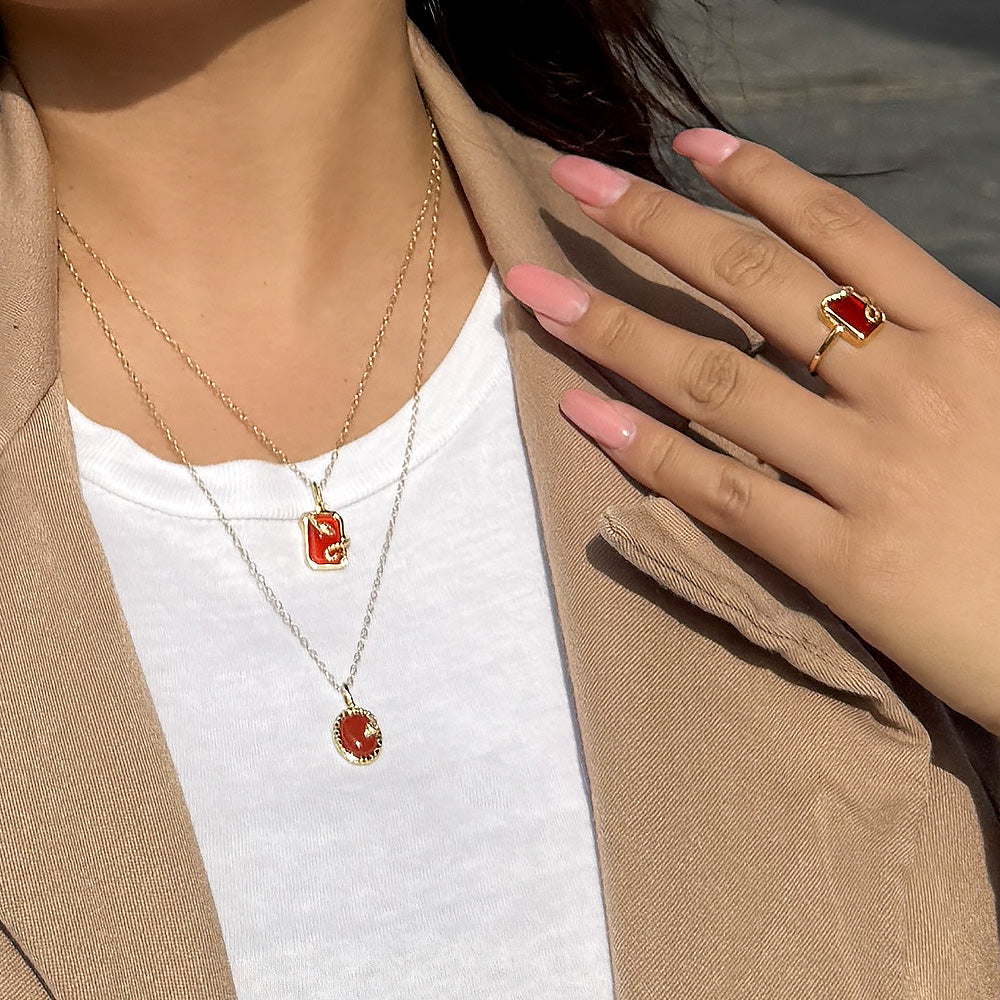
0, 0, 491, 464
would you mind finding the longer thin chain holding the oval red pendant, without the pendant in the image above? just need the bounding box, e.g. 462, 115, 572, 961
59, 121, 441, 705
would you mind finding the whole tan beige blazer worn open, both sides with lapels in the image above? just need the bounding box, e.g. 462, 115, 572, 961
0, 17, 1000, 1000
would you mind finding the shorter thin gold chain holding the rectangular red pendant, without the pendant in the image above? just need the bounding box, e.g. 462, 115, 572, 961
56, 107, 441, 504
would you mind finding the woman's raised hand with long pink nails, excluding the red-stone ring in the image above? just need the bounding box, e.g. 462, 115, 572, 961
505, 129, 1000, 734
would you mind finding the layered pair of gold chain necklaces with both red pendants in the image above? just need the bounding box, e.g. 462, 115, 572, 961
56, 107, 441, 764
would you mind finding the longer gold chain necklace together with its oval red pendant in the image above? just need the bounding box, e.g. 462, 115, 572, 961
59, 121, 441, 764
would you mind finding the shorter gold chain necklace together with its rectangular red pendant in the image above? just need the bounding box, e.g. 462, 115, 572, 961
56, 106, 441, 570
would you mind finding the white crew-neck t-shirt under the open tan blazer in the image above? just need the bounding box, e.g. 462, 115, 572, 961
70, 269, 612, 1000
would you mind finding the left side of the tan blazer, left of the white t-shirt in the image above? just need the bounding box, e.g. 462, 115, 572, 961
0, 70, 235, 1000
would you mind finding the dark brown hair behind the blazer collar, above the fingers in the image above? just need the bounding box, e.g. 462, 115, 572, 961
406, 0, 722, 183
